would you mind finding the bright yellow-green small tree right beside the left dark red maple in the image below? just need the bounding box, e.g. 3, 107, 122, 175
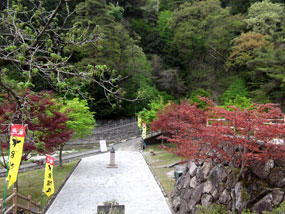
60, 98, 96, 139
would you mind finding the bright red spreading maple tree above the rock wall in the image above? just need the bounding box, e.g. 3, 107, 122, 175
152, 98, 285, 213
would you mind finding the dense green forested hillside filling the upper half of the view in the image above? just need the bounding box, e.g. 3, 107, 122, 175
0, 0, 285, 118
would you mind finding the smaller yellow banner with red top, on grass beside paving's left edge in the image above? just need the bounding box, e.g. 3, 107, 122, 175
43, 156, 54, 197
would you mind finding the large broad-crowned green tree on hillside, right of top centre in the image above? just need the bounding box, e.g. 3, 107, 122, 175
166, 0, 243, 93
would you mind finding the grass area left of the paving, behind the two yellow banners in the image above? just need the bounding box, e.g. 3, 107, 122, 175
0, 161, 78, 206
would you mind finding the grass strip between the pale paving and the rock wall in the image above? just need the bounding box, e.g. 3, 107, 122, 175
143, 143, 183, 197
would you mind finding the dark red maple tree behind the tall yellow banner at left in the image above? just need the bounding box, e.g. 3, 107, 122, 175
0, 90, 73, 168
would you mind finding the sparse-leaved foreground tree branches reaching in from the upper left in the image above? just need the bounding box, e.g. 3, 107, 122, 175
0, 0, 121, 113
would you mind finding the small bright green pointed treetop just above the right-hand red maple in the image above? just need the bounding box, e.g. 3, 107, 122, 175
221, 78, 249, 104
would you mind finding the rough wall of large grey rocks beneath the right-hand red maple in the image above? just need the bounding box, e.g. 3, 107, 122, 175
171, 160, 285, 214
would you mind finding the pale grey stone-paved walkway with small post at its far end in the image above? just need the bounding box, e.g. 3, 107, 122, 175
47, 151, 171, 214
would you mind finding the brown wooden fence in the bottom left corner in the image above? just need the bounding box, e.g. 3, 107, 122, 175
0, 188, 41, 214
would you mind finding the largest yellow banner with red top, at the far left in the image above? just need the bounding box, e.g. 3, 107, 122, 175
7, 125, 25, 189
